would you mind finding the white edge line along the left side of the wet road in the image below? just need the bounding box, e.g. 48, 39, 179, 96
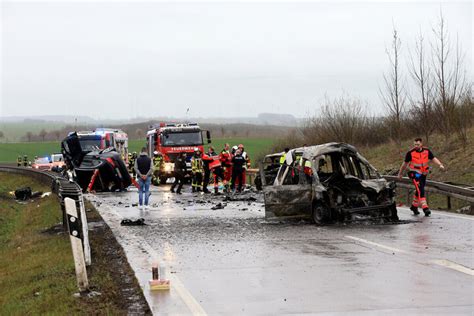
103, 202, 207, 316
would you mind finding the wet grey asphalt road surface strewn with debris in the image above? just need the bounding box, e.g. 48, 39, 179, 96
87, 187, 474, 315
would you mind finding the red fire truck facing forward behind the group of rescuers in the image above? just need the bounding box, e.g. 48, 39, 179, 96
147, 123, 211, 183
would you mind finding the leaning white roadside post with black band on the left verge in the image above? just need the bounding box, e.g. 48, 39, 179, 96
64, 198, 89, 292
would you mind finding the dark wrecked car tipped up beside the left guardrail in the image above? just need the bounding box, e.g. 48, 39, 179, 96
61, 133, 132, 191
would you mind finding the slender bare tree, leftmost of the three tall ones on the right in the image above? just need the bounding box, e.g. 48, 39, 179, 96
379, 28, 406, 150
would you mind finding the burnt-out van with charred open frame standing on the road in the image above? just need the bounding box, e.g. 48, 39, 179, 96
260, 143, 398, 225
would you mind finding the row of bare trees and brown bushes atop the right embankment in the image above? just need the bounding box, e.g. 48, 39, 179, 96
275, 13, 474, 151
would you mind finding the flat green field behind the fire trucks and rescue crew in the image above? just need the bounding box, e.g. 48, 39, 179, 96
0, 138, 274, 166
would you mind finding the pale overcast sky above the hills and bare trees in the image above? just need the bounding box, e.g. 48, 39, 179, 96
0, 1, 473, 119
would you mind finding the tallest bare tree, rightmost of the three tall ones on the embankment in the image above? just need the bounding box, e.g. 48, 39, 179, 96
432, 12, 467, 140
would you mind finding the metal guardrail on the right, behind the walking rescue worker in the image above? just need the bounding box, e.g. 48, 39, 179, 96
383, 175, 474, 209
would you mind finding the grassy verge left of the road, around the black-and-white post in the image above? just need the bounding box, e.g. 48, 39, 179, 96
0, 172, 148, 315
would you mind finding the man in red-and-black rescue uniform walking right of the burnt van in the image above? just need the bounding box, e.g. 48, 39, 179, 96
398, 138, 445, 216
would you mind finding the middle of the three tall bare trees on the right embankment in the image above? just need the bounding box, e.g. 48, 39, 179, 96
409, 32, 435, 144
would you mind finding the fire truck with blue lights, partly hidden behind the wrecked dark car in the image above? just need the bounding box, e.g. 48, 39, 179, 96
77, 128, 128, 163
